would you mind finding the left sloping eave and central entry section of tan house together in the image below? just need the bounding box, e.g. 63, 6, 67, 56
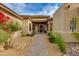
0, 3, 53, 35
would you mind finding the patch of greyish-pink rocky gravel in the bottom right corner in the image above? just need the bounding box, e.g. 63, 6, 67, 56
65, 42, 79, 56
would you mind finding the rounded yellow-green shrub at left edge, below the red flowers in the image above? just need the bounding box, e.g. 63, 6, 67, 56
0, 29, 10, 43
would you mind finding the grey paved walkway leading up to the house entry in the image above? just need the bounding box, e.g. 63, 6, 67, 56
29, 34, 48, 56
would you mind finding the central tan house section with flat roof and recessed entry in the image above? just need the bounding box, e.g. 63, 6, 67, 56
21, 15, 53, 35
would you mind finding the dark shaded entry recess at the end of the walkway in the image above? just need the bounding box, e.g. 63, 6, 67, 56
33, 22, 47, 33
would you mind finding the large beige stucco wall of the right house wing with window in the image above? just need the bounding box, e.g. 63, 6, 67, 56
53, 3, 79, 42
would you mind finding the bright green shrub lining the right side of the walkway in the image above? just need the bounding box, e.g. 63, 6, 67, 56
49, 32, 65, 53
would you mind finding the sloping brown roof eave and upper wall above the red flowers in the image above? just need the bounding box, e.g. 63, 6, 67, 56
0, 3, 22, 26
